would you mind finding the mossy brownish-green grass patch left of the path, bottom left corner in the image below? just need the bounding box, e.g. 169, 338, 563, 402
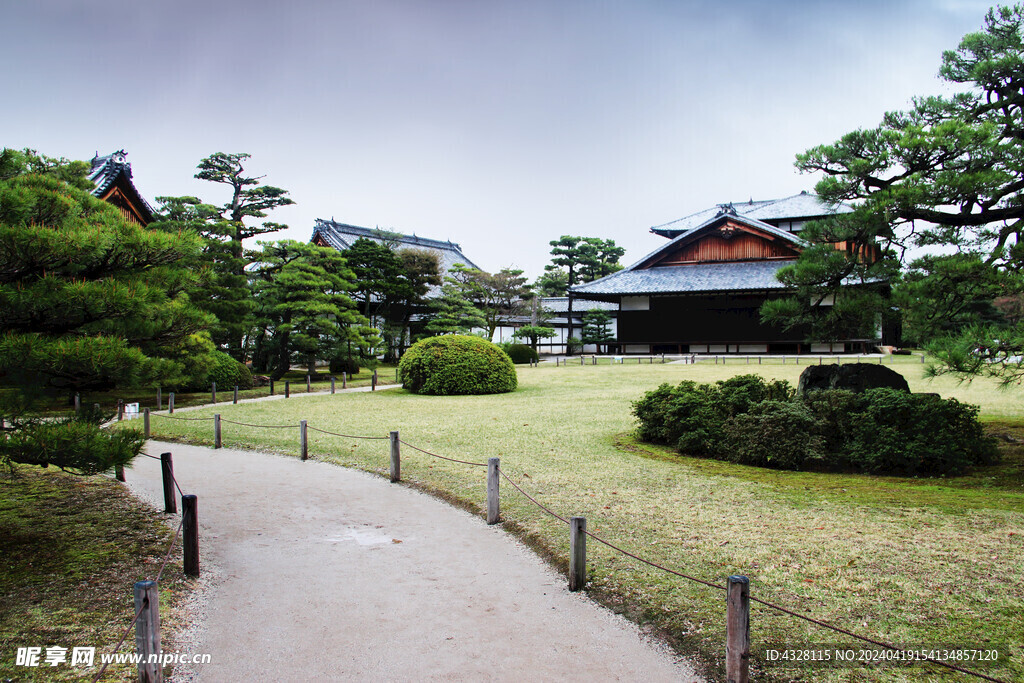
0, 466, 190, 681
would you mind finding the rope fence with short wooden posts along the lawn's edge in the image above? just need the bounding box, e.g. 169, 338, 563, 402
123, 405, 1007, 683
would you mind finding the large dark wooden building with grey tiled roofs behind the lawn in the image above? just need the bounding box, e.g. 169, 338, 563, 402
571, 193, 882, 353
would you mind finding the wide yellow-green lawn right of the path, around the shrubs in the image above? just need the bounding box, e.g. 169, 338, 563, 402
136, 356, 1024, 681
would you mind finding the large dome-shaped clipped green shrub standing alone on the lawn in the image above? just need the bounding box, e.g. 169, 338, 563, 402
398, 335, 518, 396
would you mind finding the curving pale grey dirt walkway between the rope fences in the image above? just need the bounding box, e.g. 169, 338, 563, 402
127, 441, 699, 681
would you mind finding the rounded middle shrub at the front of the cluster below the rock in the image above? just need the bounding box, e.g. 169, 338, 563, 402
723, 400, 824, 470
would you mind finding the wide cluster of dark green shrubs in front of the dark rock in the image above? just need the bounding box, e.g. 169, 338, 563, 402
633, 375, 998, 476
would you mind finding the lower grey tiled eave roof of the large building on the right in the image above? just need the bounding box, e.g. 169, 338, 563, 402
572, 259, 794, 297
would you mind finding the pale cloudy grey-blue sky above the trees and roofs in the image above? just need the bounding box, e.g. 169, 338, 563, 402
0, 0, 989, 278
